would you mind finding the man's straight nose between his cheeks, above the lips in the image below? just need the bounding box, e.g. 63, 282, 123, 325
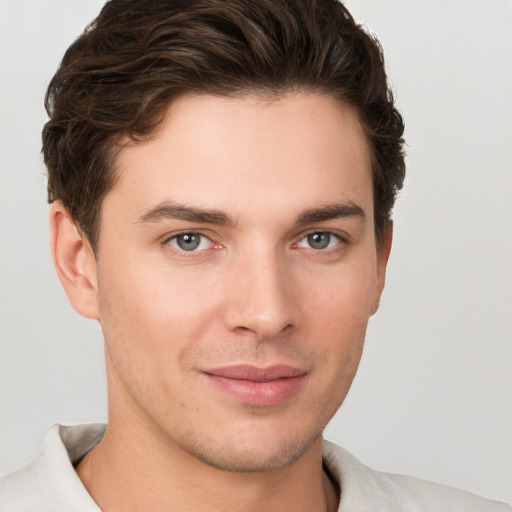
224, 248, 299, 340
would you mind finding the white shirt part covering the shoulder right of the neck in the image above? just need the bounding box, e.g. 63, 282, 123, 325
324, 441, 512, 512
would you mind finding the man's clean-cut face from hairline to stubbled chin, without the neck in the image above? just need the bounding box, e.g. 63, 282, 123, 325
88, 93, 386, 471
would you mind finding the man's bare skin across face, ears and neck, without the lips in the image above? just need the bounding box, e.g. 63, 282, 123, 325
50, 93, 391, 512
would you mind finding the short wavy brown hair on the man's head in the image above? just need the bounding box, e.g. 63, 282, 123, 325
43, 0, 405, 249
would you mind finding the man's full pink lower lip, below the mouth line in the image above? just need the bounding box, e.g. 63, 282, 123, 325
204, 373, 306, 407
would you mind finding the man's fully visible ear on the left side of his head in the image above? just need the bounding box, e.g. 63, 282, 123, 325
50, 201, 99, 320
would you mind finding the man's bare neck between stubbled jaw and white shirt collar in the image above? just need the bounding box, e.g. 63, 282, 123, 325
77, 412, 338, 512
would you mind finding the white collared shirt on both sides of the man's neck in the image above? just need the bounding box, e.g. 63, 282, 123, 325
0, 424, 512, 512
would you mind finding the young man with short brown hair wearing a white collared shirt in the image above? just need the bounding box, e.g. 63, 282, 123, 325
1, 0, 508, 511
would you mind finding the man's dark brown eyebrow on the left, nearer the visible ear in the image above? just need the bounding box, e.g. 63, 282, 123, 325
136, 201, 236, 226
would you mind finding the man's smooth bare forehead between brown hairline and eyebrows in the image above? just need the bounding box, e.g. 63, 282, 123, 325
105, 93, 372, 224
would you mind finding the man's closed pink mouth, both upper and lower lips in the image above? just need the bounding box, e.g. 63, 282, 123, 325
202, 365, 307, 407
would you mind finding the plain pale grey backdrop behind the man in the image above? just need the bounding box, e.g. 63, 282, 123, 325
0, 0, 512, 502
